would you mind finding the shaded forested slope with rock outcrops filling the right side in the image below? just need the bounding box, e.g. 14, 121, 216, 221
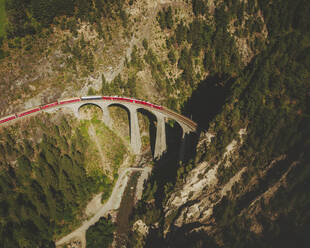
126, 1, 310, 247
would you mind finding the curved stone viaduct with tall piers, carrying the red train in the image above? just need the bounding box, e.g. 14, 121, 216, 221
0, 96, 197, 158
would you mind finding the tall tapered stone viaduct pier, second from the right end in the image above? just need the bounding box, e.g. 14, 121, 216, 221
154, 114, 167, 159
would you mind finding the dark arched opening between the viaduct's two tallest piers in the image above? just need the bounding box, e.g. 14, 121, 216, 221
137, 107, 158, 157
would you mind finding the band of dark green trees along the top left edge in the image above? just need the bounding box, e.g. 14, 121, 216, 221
6, 0, 127, 38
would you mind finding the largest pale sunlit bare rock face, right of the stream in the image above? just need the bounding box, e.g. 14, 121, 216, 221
165, 129, 246, 232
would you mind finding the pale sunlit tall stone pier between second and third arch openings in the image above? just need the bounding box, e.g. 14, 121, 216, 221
128, 107, 141, 154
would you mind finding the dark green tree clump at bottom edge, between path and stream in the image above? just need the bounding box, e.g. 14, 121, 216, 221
86, 217, 116, 248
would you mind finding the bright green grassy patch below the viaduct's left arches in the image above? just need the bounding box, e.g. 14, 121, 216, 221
79, 105, 128, 202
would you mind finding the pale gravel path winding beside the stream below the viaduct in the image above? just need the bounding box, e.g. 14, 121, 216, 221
55, 167, 151, 248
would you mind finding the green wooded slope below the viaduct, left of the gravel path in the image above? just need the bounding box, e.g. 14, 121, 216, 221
0, 114, 126, 247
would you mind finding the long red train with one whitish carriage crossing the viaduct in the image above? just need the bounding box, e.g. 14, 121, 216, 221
0, 96, 163, 124
